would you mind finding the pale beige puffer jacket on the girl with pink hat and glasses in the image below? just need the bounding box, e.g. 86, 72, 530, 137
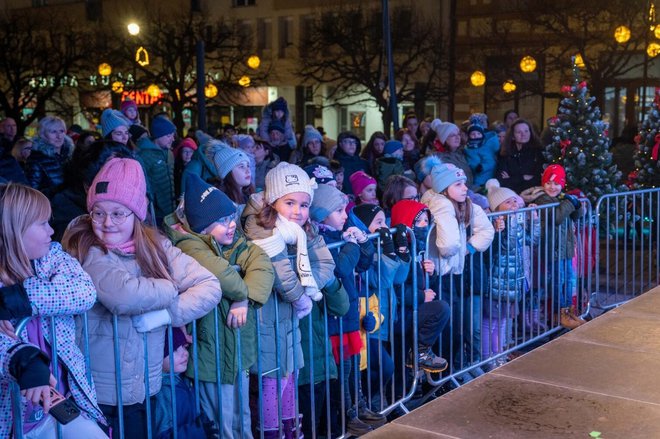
83, 239, 222, 406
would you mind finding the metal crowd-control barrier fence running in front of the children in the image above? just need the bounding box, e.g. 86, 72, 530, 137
12, 190, 660, 438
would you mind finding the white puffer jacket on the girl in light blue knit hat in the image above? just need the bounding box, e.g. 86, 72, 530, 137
421, 189, 495, 276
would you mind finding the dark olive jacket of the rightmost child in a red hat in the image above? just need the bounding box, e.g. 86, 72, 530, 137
520, 186, 584, 260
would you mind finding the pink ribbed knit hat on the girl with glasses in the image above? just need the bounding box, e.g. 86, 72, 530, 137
87, 158, 147, 221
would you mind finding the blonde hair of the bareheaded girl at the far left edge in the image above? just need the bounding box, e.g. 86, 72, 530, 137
0, 183, 51, 285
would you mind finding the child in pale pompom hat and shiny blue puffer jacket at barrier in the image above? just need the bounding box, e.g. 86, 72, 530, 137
481, 178, 541, 364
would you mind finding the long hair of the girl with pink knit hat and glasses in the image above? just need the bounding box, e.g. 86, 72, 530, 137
62, 215, 172, 281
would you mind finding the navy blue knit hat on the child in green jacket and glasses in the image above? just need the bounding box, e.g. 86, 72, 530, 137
183, 173, 236, 233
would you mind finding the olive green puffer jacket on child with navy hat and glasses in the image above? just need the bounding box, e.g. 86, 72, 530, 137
165, 214, 274, 384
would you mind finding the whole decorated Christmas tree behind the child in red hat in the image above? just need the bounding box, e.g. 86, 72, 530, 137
544, 65, 626, 205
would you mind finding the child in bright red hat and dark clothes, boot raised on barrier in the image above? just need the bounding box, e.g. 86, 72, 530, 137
392, 200, 451, 373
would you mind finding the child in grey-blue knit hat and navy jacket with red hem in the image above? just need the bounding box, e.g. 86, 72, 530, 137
311, 184, 378, 436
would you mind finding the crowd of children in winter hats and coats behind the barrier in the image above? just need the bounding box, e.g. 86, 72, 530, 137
0, 99, 583, 438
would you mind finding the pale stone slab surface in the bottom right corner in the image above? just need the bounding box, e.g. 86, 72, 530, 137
365, 287, 660, 439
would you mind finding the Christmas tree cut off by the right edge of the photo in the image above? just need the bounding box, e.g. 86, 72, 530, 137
628, 89, 660, 189
